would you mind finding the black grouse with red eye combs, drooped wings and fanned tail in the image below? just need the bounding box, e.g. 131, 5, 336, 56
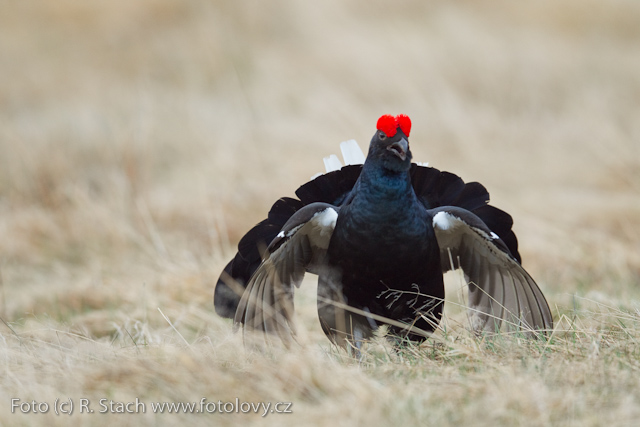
214, 115, 553, 349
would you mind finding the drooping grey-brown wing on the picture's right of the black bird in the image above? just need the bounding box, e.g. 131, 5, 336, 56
429, 206, 553, 332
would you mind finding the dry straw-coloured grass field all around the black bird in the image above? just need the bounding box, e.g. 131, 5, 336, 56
0, 0, 640, 426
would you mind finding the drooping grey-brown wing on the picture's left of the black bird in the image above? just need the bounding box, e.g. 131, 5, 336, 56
234, 202, 339, 345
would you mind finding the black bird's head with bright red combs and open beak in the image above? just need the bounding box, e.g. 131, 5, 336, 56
367, 114, 412, 172
